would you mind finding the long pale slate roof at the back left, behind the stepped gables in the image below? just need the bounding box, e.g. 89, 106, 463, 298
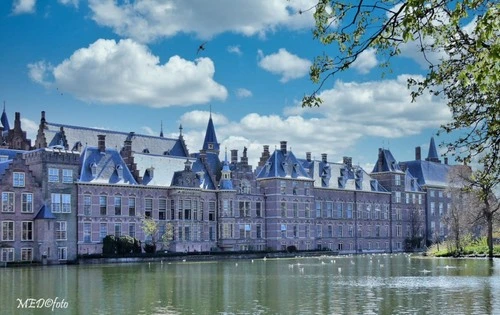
44, 122, 189, 157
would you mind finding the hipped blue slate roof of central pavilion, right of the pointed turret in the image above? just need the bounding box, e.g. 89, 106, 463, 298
257, 150, 310, 179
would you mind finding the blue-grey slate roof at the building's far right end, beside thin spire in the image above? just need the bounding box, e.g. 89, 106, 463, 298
402, 160, 453, 187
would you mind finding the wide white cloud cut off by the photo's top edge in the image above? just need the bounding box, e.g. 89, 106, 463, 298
89, 0, 317, 42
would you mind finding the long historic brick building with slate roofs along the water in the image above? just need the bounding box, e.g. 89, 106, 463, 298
0, 112, 460, 263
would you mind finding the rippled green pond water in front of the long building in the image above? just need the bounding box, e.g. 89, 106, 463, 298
0, 255, 500, 315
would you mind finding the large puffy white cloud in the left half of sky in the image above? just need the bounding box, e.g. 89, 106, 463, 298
28, 39, 227, 108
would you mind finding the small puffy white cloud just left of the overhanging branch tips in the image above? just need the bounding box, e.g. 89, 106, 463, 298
257, 48, 311, 83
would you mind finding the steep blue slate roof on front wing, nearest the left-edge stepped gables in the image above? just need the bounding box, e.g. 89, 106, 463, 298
79, 147, 137, 185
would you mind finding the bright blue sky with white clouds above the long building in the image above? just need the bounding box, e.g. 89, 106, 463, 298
0, 0, 450, 171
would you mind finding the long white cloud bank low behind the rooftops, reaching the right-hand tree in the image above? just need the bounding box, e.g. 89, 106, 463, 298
175, 75, 450, 167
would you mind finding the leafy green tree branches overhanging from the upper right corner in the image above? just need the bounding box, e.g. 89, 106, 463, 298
299, 0, 500, 203
